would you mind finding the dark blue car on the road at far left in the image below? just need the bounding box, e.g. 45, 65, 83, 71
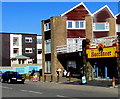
1, 71, 25, 84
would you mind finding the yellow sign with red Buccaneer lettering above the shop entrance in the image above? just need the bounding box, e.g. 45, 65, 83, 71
86, 47, 117, 58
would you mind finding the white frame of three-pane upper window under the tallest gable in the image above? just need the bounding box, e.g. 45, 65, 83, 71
67, 20, 86, 29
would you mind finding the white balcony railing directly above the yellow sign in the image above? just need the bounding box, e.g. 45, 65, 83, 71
90, 35, 118, 48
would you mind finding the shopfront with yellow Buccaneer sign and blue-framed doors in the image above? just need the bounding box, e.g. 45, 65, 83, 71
86, 46, 117, 79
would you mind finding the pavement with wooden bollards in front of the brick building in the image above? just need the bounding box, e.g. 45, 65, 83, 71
26, 77, 118, 88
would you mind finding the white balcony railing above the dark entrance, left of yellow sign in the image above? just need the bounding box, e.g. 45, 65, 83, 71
56, 44, 82, 53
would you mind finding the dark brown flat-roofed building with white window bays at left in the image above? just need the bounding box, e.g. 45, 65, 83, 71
0, 33, 42, 66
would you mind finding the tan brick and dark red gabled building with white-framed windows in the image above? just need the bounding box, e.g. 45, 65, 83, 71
42, 3, 119, 79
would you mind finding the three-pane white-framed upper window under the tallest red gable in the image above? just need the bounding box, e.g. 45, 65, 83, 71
67, 21, 85, 29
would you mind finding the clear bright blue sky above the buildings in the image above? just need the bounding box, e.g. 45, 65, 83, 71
0, 2, 118, 35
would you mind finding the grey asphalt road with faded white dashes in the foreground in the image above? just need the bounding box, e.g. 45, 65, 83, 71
0, 82, 118, 99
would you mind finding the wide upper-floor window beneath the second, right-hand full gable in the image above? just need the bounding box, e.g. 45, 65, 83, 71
93, 23, 109, 31
